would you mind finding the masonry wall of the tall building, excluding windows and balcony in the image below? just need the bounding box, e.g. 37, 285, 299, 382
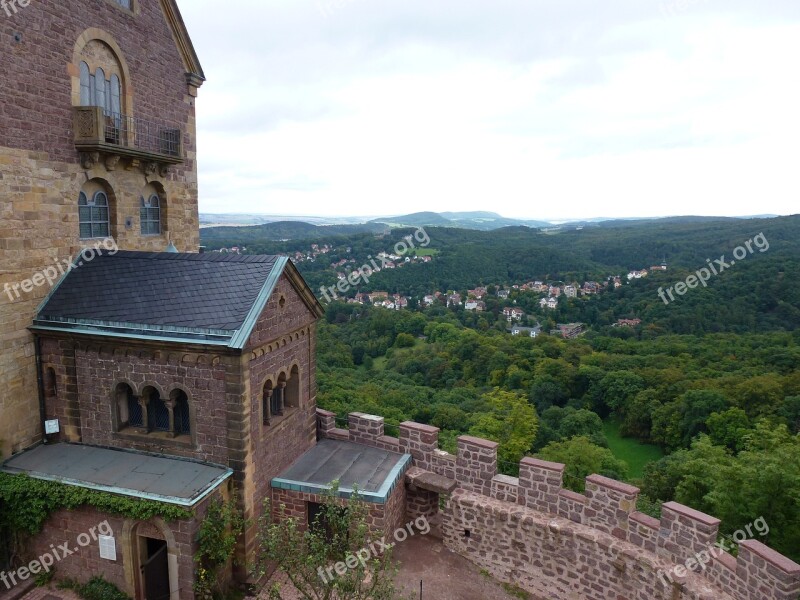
0, 0, 199, 456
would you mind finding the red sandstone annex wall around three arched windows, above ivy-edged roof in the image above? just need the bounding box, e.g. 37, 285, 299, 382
42, 338, 241, 465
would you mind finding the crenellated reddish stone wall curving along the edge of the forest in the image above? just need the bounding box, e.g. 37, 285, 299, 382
317, 409, 800, 600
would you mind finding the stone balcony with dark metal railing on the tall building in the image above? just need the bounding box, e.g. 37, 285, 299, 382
73, 106, 183, 176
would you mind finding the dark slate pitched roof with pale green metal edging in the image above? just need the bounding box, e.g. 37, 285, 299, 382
32, 251, 316, 345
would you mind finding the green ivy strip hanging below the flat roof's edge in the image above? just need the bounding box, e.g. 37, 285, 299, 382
0, 473, 192, 535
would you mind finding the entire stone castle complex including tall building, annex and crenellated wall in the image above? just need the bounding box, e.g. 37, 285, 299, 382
0, 0, 800, 600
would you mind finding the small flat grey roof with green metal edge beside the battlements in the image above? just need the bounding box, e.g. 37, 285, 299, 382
272, 440, 411, 504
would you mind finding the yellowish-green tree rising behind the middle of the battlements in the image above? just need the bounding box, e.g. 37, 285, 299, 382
470, 389, 539, 471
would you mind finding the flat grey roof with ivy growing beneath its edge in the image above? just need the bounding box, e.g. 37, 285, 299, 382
2, 444, 233, 507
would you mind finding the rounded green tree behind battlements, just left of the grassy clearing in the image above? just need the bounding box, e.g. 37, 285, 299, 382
539, 435, 628, 492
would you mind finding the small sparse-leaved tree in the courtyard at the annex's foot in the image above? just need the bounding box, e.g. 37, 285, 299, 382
257, 482, 400, 600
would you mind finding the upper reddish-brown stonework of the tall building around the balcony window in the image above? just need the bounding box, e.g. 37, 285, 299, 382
0, 0, 195, 166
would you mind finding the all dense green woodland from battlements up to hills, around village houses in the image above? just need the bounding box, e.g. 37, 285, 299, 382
206, 217, 800, 560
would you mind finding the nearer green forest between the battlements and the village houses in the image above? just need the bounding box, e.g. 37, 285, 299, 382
317, 303, 800, 559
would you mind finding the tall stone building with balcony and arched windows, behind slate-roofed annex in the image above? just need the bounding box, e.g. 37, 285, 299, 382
0, 0, 204, 456
